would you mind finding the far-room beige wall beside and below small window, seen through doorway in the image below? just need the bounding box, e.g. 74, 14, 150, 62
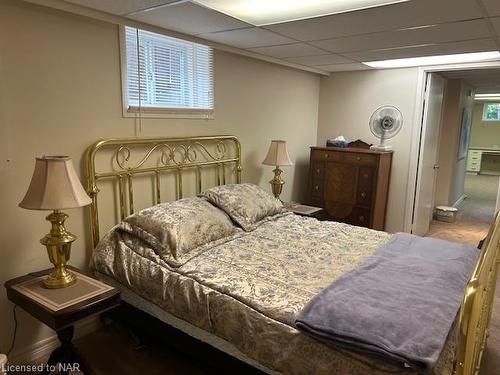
470, 103, 500, 148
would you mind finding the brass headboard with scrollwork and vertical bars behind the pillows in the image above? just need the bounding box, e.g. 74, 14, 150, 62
86, 135, 241, 247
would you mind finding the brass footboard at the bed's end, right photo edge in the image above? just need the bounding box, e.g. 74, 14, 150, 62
453, 214, 500, 375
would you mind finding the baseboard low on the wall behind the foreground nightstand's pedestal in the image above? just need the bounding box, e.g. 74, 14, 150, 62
8, 317, 99, 364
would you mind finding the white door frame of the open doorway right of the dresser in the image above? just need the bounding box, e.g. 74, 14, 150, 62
404, 61, 500, 232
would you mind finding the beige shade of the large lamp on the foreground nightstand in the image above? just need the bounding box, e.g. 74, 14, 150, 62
19, 156, 92, 210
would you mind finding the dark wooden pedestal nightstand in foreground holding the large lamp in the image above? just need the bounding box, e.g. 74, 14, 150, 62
5, 267, 120, 375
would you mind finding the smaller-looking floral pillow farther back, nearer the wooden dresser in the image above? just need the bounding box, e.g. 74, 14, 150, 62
200, 184, 286, 232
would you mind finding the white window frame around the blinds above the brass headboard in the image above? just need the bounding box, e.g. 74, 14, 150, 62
119, 25, 215, 120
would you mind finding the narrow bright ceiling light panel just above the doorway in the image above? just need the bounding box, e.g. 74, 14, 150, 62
363, 51, 500, 69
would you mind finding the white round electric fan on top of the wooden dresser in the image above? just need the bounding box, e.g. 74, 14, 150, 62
370, 105, 403, 151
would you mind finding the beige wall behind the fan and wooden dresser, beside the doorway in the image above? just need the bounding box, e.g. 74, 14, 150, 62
318, 68, 417, 232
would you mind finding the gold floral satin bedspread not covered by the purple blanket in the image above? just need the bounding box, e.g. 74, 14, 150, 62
93, 214, 455, 374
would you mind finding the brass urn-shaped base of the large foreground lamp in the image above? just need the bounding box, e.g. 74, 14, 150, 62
40, 210, 76, 289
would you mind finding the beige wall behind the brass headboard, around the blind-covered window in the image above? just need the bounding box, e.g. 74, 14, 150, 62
0, 0, 320, 358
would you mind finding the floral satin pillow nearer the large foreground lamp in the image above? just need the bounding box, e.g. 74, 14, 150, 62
120, 197, 238, 267
